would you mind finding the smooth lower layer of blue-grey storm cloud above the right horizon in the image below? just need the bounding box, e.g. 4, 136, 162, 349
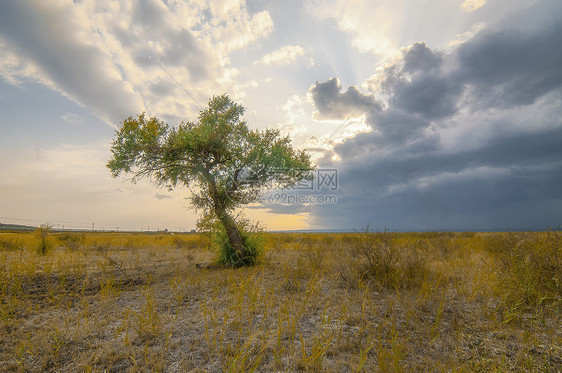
314, 124, 562, 230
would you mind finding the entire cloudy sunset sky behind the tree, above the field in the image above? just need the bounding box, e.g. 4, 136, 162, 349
0, 0, 562, 231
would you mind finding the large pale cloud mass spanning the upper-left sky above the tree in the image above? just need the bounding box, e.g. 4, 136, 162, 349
0, 0, 273, 125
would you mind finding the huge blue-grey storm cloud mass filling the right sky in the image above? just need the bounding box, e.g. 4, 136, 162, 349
304, 1, 562, 230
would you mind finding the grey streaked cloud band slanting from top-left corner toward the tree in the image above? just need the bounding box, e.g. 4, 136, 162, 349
0, 1, 147, 125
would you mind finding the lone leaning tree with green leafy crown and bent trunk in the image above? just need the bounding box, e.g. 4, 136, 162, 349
107, 94, 312, 266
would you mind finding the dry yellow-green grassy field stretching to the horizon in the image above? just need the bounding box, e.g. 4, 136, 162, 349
0, 228, 562, 372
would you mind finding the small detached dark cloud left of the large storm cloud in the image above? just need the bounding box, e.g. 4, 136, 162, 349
309, 78, 380, 120
